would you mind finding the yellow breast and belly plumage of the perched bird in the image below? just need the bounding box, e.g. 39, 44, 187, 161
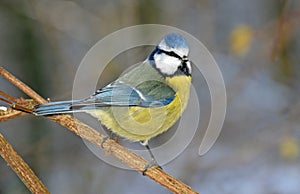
88, 76, 191, 141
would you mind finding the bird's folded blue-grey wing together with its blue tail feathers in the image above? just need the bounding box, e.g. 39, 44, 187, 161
34, 81, 175, 115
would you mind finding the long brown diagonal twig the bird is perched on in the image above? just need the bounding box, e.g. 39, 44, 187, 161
0, 67, 197, 193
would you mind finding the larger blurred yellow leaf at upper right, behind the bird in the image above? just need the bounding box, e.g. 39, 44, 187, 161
230, 24, 253, 56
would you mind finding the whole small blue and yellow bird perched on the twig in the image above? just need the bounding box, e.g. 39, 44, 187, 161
33, 33, 192, 167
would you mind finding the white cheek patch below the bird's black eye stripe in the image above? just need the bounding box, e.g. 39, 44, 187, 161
154, 53, 181, 75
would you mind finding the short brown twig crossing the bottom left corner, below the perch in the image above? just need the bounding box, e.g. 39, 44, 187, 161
0, 133, 49, 193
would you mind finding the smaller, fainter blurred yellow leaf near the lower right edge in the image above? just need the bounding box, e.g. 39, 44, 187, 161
279, 137, 299, 160
